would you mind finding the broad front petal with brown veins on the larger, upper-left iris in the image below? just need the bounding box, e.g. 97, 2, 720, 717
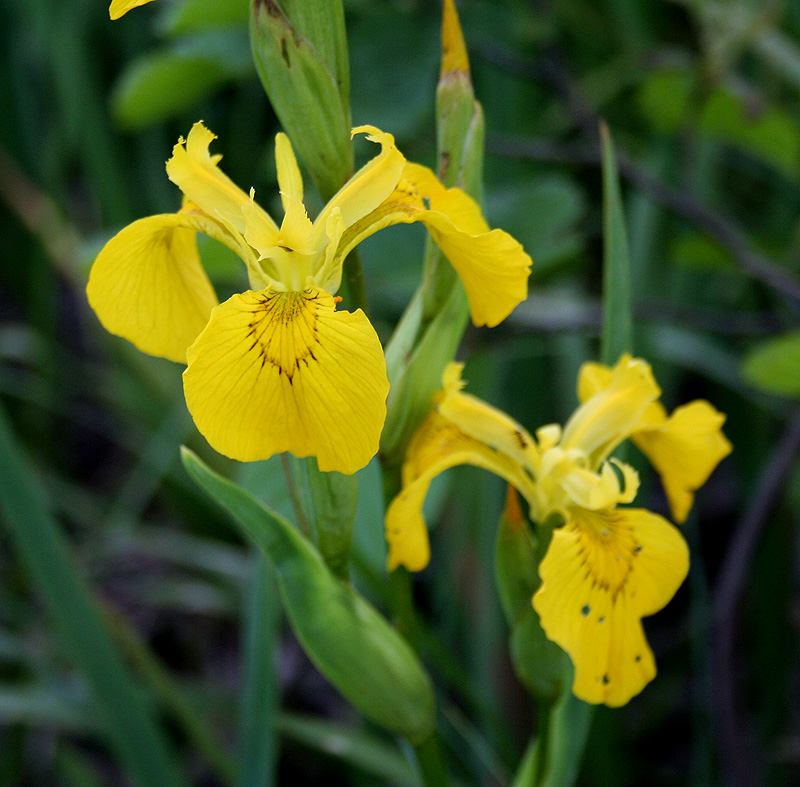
183, 287, 389, 473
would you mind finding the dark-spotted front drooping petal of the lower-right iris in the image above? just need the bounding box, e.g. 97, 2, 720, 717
533, 508, 689, 707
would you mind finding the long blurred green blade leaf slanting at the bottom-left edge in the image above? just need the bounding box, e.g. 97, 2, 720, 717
0, 410, 186, 787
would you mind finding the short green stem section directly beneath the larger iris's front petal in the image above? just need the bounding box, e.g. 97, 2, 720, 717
298, 457, 358, 581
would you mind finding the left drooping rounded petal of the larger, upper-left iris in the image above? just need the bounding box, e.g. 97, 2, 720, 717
86, 212, 221, 363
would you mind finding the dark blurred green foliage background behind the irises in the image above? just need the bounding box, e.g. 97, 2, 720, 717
0, 0, 800, 787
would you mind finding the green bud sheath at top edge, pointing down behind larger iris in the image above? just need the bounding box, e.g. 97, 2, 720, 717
250, 0, 353, 201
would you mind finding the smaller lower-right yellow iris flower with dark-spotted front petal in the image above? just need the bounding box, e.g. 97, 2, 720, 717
386, 355, 731, 706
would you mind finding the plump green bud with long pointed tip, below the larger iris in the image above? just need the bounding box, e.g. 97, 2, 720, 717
181, 447, 435, 743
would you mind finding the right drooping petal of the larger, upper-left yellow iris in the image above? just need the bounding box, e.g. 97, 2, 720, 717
332, 163, 531, 327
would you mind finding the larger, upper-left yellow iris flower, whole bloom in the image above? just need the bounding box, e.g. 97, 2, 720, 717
87, 123, 530, 473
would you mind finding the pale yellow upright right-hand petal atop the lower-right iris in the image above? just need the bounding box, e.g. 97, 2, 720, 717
561, 355, 661, 467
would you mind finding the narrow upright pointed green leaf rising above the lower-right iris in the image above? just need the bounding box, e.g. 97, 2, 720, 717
600, 123, 633, 366
